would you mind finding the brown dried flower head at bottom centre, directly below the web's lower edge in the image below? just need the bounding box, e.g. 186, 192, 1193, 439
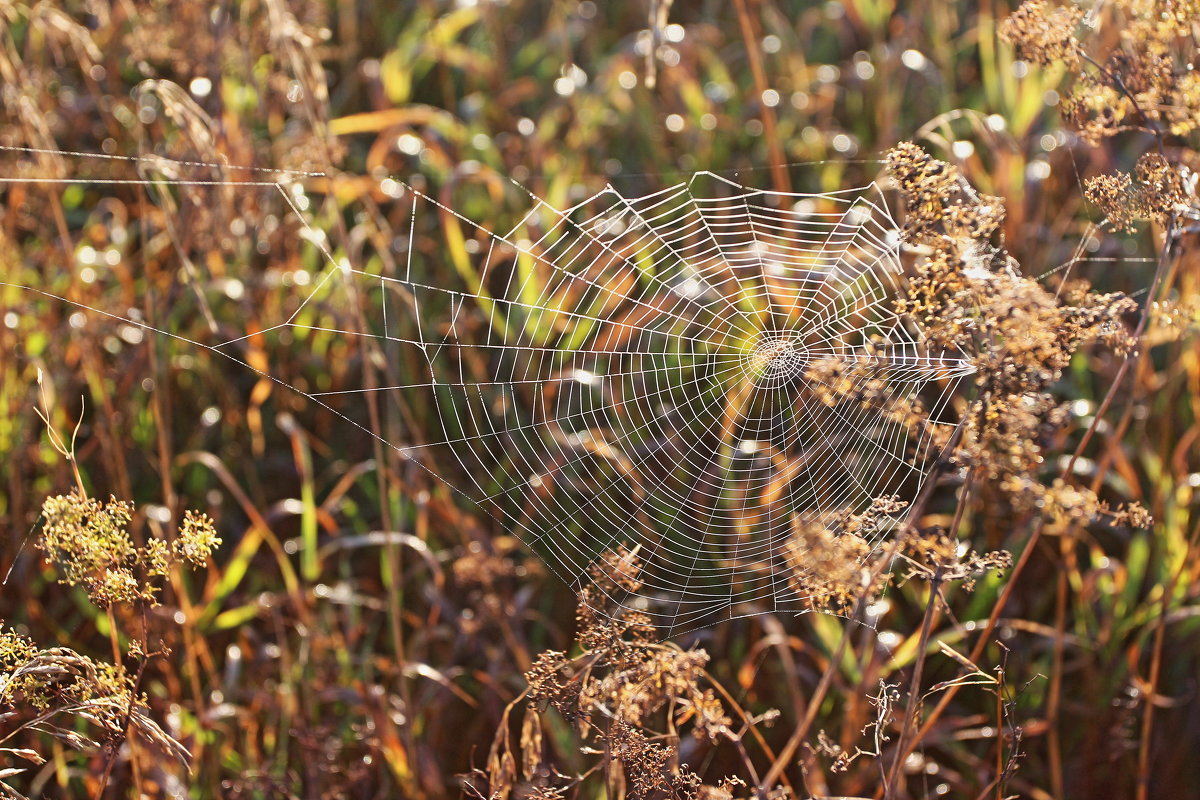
474, 551, 758, 800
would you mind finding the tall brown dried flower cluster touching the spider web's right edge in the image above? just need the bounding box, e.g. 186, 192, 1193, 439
887, 144, 1147, 532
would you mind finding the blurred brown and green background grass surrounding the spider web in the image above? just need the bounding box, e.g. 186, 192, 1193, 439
0, 0, 1200, 798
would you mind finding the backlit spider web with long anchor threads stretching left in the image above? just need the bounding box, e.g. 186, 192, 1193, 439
2, 149, 973, 636
